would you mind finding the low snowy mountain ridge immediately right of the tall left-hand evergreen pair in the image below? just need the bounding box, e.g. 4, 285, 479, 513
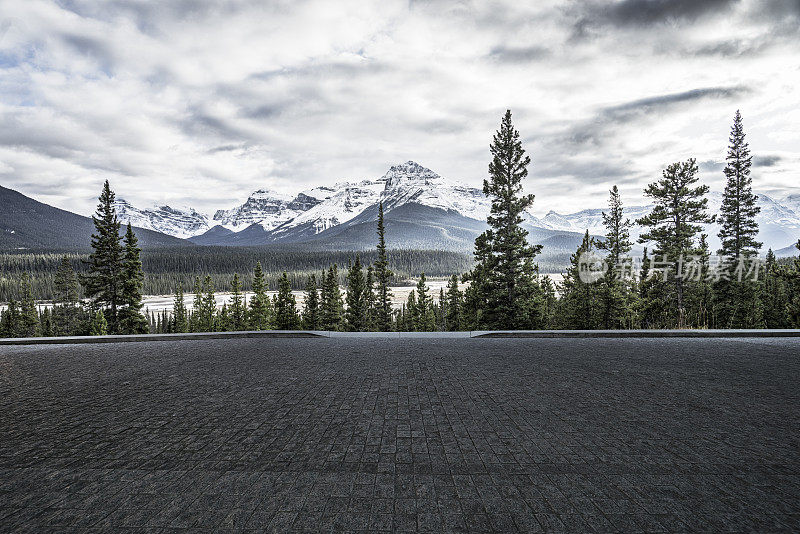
114, 198, 210, 239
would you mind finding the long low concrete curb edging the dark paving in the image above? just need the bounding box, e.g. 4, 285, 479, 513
0, 329, 800, 346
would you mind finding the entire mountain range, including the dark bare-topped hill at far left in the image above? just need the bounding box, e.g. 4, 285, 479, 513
0, 161, 800, 268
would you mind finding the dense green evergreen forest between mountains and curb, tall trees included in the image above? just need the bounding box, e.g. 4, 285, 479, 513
0, 111, 800, 337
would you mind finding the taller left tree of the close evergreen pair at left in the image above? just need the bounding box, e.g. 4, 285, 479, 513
83, 180, 123, 332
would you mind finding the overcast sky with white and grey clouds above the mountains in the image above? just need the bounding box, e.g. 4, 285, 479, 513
0, 0, 800, 218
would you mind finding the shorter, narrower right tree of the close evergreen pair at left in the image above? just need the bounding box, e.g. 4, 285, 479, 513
117, 223, 148, 334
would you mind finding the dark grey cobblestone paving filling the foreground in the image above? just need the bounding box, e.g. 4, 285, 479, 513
0, 339, 800, 532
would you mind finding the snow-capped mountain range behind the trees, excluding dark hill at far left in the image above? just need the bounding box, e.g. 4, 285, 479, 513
111, 161, 800, 254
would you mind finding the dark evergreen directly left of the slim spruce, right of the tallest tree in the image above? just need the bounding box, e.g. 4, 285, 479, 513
560, 230, 601, 330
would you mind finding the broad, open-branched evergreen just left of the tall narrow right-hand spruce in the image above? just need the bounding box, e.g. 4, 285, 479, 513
636, 158, 714, 328
